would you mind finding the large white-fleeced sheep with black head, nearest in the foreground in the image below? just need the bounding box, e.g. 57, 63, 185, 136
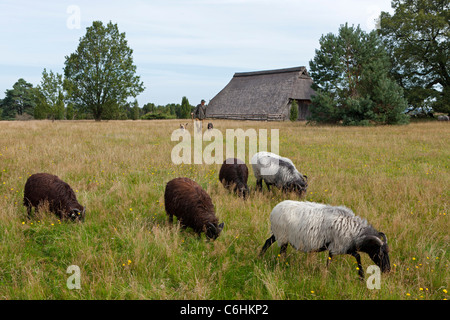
260, 200, 390, 279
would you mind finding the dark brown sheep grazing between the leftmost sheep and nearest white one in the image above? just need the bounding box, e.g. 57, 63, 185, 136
164, 178, 224, 240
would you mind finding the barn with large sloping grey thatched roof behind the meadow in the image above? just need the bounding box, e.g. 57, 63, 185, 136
206, 67, 314, 120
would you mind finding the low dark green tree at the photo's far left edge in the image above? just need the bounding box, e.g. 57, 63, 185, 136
2, 78, 37, 119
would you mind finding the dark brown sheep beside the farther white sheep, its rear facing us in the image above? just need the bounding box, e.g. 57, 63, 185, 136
219, 158, 249, 199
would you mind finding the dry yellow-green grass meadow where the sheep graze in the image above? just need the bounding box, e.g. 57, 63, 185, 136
0, 120, 450, 300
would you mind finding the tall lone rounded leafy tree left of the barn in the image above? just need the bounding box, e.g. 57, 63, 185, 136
64, 21, 144, 121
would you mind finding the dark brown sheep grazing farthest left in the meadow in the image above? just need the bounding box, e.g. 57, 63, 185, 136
23, 173, 86, 221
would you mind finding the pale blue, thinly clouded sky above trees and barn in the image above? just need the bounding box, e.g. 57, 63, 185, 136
0, 0, 393, 107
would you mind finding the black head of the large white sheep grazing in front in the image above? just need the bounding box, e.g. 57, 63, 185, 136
360, 232, 391, 272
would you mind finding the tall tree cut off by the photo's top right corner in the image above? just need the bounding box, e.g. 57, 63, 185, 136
378, 0, 450, 114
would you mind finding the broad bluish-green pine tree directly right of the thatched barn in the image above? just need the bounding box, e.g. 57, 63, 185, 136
309, 24, 408, 125
